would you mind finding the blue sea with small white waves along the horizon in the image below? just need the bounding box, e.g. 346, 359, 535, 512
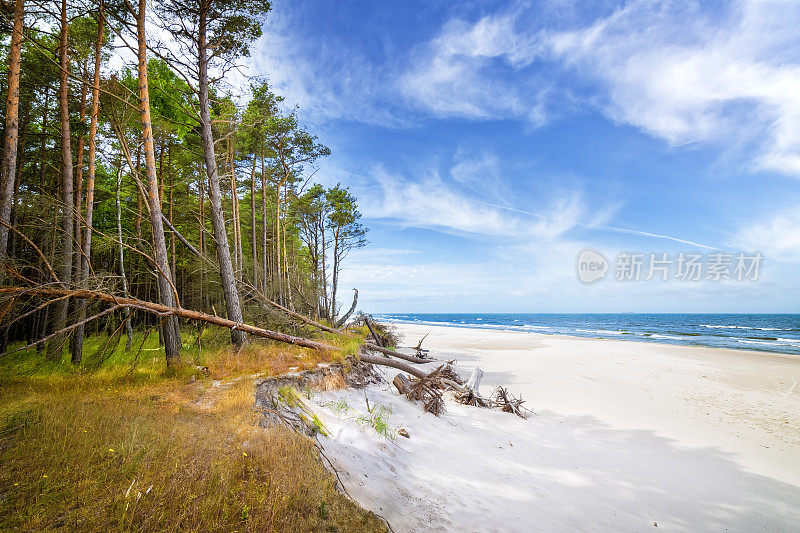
375, 313, 800, 355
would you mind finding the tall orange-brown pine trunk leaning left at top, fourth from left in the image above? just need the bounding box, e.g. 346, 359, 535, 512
136, 0, 181, 366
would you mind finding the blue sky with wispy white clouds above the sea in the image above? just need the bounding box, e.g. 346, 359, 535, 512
248, 0, 800, 313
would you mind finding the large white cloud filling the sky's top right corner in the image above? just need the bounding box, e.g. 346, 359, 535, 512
547, 1, 800, 173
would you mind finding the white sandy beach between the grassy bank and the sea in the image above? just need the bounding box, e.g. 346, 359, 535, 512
313, 325, 800, 532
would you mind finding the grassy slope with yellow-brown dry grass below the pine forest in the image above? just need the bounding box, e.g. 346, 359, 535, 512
0, 331, 385, 531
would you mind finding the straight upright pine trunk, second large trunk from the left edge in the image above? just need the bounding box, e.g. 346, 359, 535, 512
47, 0, 75, 361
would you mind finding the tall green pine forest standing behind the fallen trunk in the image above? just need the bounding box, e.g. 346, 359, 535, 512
0, 0, 367, 365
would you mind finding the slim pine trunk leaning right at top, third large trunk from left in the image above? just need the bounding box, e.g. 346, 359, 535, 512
72, 0, 103, 365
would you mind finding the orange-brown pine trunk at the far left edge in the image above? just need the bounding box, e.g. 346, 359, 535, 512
0, 0, 25, 284
